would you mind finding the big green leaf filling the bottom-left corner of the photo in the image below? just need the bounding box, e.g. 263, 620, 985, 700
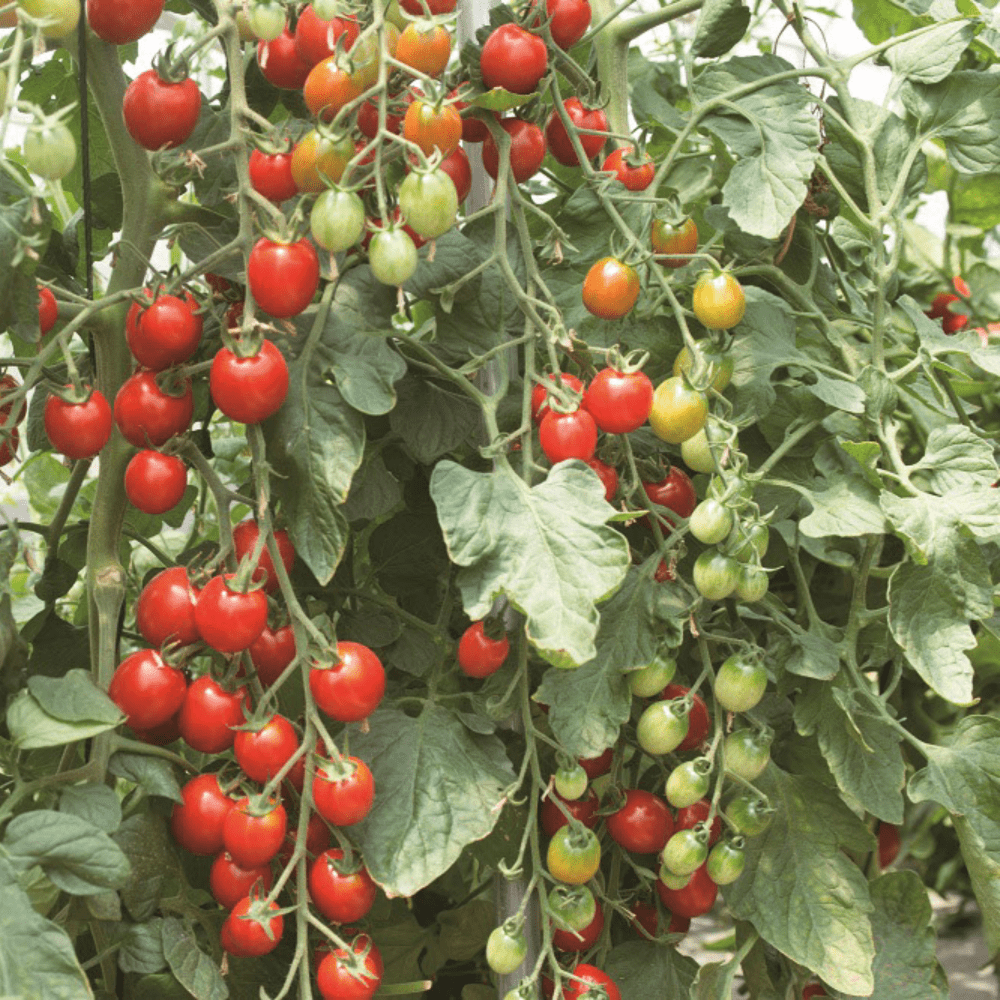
0, 859, 94, 1000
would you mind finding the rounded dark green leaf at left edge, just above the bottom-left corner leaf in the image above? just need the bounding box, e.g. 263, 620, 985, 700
3, 809, 130, 896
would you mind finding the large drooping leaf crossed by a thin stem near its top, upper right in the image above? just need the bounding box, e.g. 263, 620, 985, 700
692, 56, 824, 239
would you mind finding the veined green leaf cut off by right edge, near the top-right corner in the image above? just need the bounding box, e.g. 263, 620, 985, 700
900, 70, 1000, 174
